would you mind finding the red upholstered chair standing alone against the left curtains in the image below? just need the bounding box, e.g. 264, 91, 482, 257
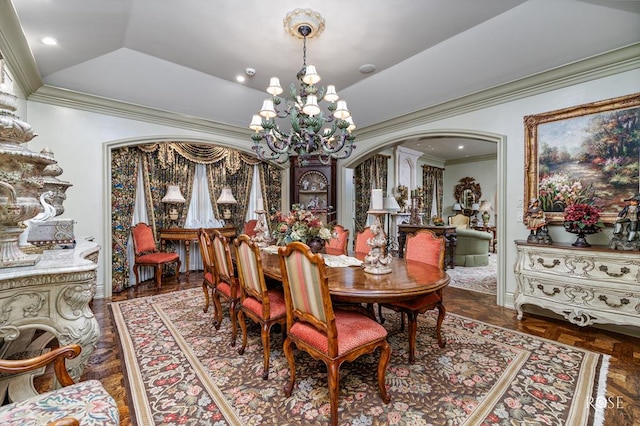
131, 222, 181, 290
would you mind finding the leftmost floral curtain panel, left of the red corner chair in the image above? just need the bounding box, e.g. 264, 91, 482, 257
111, 147, 140, 292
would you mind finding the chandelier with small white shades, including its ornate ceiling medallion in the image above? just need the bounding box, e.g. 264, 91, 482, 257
249, 9, 356, 165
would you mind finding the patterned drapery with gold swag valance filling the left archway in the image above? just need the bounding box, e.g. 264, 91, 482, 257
111, 142, 282, 292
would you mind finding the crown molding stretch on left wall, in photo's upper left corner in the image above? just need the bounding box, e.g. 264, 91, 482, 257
0, 0, 43, 97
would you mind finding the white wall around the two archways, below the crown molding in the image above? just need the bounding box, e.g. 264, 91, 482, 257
19, 70, 640, 306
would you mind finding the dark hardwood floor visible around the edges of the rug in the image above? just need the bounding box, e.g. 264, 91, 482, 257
82, 272, 640, 426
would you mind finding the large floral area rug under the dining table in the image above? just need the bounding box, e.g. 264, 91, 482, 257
111, 289, 608, 426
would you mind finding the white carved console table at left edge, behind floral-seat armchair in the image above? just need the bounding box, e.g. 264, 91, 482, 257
0, 238, 100, 400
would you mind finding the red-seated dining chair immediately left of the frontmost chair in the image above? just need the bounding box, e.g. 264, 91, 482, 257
233, 234, 287, 380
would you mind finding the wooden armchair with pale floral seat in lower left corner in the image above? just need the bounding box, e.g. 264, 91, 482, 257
0, 345, 120, 426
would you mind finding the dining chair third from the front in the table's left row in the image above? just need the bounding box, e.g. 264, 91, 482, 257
211, 230, 238, 346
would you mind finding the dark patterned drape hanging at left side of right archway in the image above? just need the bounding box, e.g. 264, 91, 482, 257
353, 154, 391, 232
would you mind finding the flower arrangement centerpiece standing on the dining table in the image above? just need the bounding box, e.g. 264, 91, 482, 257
271, 204, 333, 246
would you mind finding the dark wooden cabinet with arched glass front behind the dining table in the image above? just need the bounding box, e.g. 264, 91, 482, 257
290, 158, 338, 223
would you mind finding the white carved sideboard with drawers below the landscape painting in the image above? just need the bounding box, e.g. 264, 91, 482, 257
514, 241, 640, 327
